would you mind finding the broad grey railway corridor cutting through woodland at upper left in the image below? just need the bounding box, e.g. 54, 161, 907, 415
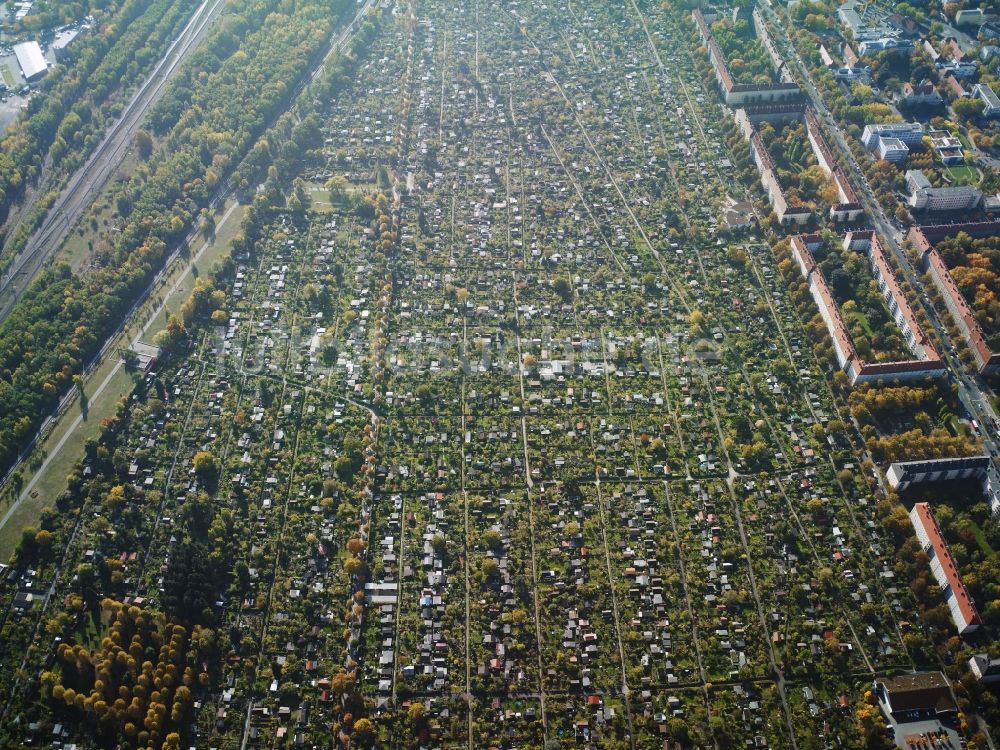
0, 0, 226, 322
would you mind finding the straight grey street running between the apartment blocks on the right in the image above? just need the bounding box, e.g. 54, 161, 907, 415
762, 5, 1000, 458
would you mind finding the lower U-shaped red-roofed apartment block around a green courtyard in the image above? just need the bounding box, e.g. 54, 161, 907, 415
792, 231, 946, 385
